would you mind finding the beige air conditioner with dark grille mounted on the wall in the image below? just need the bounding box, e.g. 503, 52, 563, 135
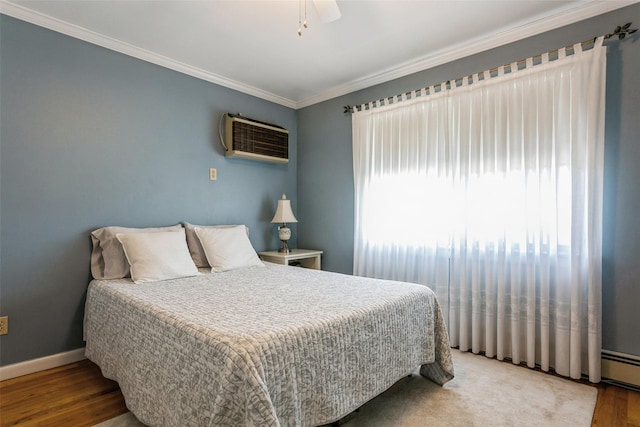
223, 113, 289, 163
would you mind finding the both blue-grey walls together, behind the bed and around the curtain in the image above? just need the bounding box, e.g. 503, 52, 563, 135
0, 4, 640, 365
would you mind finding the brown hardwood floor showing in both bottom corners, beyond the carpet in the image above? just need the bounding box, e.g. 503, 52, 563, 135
0, 360, 640, 427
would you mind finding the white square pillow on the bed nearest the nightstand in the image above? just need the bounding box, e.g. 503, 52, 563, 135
196, 225, 264, 272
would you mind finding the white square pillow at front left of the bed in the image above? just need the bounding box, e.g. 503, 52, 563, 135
116, 230, 198, 283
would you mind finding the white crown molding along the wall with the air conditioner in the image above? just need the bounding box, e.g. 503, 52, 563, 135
0, 0, 296, 108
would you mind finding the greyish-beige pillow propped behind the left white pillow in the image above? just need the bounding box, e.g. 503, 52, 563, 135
91, 224, 182, 279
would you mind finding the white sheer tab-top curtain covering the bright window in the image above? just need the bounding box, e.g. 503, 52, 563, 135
353, 38, 606, 382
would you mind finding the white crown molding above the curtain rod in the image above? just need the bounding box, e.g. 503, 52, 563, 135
295, 0, 640, 109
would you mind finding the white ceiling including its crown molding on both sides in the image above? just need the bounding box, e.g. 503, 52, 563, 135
0, 0, 638, 108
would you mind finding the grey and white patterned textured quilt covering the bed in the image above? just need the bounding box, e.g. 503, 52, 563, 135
84, 263, 453, 426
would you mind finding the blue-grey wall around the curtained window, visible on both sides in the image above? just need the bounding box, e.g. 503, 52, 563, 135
298, 4, 640, 355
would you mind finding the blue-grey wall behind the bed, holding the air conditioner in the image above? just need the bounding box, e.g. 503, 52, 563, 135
0, 15, 297, 365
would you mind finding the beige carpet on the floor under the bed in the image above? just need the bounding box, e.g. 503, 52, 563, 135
94, 350, 597, 427
